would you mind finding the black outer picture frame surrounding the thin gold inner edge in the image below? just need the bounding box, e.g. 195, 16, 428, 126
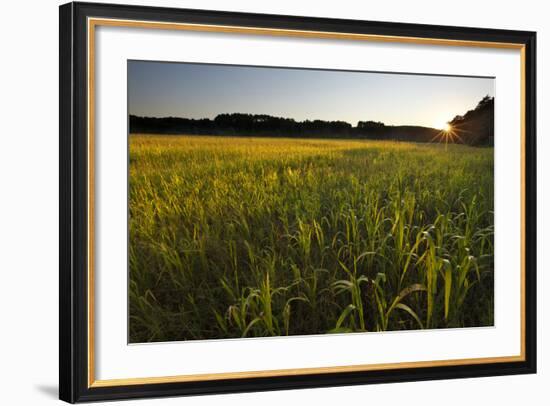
59, 3, 537, 403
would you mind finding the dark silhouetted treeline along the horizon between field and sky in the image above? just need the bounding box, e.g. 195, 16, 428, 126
130, 96, 494, 145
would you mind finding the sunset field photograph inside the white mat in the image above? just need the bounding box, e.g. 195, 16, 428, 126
127, 60, 495, 343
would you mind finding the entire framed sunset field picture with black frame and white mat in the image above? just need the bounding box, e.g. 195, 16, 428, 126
60, 3, 536, 402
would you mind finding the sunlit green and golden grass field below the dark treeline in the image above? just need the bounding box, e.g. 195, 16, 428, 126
129, 135, 494, 342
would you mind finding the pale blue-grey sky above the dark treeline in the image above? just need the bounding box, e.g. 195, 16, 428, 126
128, 61, 494, 128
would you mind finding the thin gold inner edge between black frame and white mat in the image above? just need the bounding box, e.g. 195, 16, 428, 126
87, 18, 526, 388
